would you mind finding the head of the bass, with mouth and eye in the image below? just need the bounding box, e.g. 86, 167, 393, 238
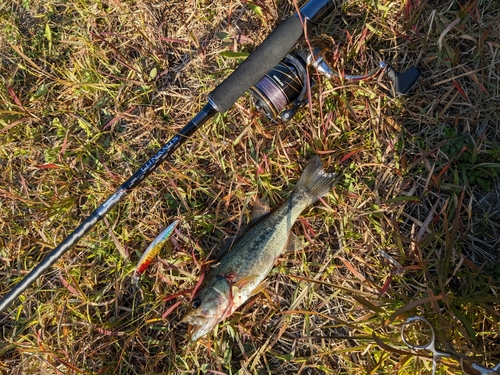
182, 276, 233, 341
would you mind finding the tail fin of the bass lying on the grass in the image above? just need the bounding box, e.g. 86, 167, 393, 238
295, 155, 337, 203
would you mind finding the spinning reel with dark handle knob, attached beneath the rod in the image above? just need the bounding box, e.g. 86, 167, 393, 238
250, 49, 420, 121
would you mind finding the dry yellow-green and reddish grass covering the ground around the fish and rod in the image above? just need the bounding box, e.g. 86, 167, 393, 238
0, 0, 500, 374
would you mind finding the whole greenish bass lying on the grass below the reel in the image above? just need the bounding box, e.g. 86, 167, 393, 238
181, 155, 337, 341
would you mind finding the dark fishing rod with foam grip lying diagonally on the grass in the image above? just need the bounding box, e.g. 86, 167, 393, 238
0, 0, 340, 312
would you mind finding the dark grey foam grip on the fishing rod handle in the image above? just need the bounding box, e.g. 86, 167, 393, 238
210, 16, 303, 112
